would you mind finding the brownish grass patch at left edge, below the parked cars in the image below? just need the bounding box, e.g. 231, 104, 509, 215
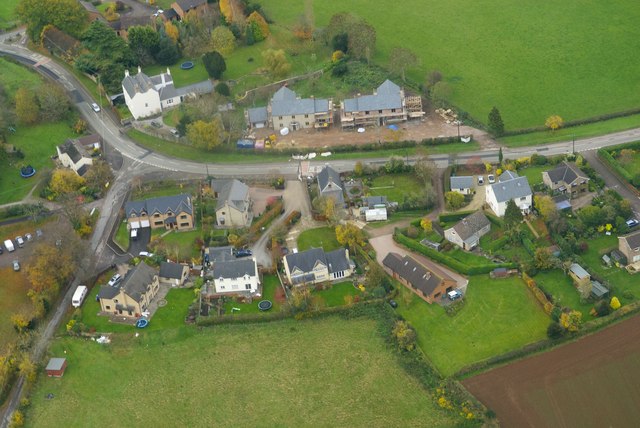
0, 268, 33, 355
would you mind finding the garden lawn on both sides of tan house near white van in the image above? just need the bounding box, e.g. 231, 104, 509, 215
80, 284, 196, 333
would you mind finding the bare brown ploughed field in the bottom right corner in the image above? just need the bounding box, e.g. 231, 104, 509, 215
462, 316, 640, 427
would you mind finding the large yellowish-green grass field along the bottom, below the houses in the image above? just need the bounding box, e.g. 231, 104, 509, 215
26, 316, 456, 427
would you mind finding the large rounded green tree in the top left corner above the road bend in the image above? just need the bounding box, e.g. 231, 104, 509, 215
16, 0, 87, 43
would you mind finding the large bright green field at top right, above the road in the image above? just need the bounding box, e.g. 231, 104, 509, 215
263, 0, 640, 129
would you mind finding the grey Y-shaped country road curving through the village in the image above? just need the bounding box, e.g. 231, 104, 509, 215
0, 29, 640, 428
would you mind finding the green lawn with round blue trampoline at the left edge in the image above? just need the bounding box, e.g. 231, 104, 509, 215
0, 122, 77, 204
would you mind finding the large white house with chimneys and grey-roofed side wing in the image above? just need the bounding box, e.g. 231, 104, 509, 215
122, 67, 213, 119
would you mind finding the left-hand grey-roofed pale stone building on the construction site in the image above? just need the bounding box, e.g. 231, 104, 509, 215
245, 86, 333, 131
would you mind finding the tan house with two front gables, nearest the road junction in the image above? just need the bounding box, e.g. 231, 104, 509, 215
124, 194, 194, 230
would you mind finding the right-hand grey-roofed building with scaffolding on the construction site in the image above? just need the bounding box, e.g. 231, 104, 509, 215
340, 80, 424, 129
